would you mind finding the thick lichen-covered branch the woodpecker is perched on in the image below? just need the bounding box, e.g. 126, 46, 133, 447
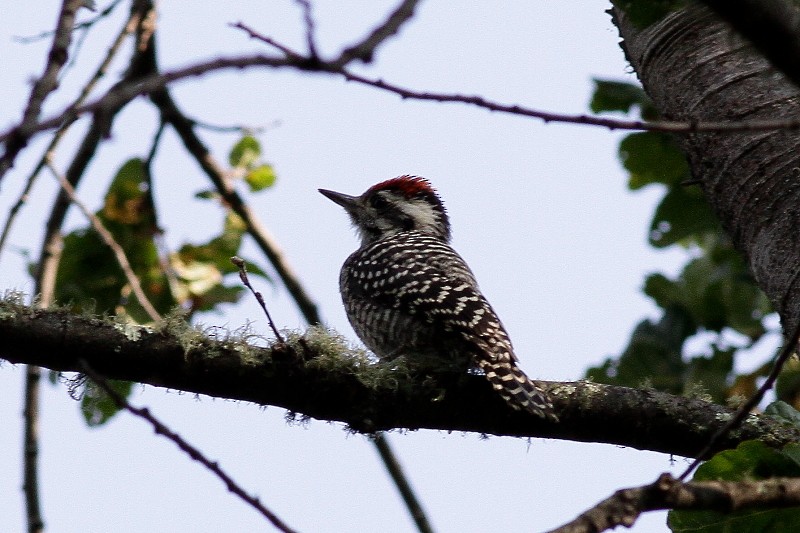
0, 301, 800, 456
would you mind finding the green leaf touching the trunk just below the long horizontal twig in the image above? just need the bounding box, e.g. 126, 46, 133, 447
619, 131, 689, 190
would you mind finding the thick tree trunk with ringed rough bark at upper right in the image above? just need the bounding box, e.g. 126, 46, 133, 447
613, 4, 800, 331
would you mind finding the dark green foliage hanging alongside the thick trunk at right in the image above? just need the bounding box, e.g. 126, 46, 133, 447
587, 81, 776, 403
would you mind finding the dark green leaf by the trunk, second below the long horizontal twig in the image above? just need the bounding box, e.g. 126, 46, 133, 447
650, 186, 720, 248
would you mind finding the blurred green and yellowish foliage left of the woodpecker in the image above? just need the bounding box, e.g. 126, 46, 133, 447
55, 135, 275, 426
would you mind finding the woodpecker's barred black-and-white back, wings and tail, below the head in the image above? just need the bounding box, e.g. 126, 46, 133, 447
342, 232, 558, 421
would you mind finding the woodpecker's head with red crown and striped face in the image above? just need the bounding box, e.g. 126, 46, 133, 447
319, 176, 450, 246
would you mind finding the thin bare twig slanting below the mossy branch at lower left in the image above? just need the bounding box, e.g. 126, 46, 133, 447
79, 359, 295, 533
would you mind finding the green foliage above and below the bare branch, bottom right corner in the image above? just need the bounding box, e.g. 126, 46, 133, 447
667, 434, 800, 533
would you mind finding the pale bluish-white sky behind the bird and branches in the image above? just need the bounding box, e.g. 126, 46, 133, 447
0, 0, 684, 533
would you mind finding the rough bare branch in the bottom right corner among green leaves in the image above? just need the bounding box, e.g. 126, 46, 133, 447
550, 474, 800, 533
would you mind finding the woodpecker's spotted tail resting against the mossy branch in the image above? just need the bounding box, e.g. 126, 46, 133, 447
477, 359, 558, 422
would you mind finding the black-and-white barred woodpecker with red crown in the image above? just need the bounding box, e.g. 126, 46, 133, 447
319, 176, 558, 421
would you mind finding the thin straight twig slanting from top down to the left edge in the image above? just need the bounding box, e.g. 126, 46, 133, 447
0, 6, 139, 260
